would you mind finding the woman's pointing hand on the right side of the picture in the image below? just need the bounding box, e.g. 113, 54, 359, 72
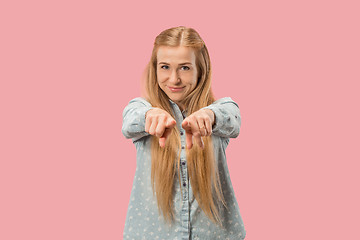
181, 109, 215, 149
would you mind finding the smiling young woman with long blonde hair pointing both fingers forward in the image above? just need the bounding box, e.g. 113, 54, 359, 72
122, 26, 246, 240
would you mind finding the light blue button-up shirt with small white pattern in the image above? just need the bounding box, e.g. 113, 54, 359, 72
122, 97, 246, 240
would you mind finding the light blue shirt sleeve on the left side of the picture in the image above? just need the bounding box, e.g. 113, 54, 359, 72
122, 97, 153, 142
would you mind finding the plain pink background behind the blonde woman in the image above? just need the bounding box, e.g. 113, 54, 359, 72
0, 0, 360, 240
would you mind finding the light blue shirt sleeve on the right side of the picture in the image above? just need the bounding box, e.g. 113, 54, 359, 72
203, 97, 241, 138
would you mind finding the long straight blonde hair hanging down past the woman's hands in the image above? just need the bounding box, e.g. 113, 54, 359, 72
145, 26, 226, 226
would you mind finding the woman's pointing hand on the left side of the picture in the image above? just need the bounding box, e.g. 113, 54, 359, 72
145, 108, 176, 147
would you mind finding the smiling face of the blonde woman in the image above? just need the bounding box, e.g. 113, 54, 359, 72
156, 46, 198, 110
